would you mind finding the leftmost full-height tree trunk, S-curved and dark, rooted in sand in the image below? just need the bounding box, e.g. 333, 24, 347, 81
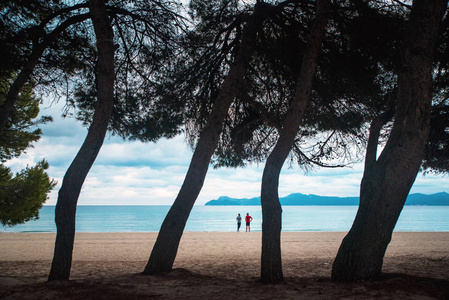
48, 0, 115, 280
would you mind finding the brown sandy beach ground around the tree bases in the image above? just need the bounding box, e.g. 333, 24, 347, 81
0, 232, 449, 299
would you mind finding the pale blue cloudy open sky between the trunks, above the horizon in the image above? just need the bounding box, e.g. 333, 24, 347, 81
7, 101, 449, 205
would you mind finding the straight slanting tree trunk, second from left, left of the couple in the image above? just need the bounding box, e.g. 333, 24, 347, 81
143, 14, 260, 275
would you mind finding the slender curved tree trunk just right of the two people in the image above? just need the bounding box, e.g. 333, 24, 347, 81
260, 0, 330, 283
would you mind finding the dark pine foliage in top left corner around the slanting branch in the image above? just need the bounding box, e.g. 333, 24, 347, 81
0, 0, 89, 87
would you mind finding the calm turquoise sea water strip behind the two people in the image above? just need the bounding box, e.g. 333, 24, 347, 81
0, 206, 449, 232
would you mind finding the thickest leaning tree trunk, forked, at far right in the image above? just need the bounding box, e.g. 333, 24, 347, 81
332, 0, 447, 281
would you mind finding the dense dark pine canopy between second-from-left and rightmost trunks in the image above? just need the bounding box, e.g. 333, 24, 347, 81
209, 2, 403, 169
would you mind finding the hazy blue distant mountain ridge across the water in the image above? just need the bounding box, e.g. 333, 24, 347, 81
205, 192, 449, 206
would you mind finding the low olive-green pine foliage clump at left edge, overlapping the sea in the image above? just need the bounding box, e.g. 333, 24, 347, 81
0, 160, 56, 226
